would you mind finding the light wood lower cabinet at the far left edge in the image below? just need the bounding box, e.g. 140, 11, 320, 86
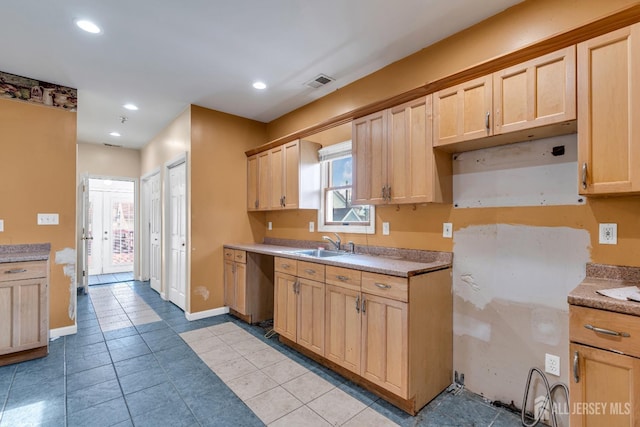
0, 261, 49, 366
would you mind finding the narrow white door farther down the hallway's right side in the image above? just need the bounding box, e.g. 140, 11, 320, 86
147, 173, 162, 292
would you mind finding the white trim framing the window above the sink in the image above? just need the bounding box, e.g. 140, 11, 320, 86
318, 141, 376, 234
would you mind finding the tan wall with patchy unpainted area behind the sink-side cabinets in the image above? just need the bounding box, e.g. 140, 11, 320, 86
258, 0, 640, 405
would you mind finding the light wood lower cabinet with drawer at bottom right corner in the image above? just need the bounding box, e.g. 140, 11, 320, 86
567, 306, 640, 427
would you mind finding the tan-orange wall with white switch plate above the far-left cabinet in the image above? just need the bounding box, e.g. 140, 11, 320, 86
0, 99, 76, 329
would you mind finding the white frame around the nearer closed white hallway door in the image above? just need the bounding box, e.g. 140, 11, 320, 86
161, 152, 191, 313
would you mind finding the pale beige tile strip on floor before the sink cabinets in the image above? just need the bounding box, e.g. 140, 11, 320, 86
180, 322, 397, 426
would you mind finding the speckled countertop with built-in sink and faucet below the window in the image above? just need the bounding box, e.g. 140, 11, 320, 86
224, 239, 453, 277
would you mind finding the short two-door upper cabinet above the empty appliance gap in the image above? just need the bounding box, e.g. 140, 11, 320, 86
433, 46, 576, 152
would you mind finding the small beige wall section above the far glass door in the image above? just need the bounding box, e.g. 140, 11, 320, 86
78, 142, 140, 179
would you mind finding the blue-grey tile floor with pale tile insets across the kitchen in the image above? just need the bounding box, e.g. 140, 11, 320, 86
0, 281, 521, 427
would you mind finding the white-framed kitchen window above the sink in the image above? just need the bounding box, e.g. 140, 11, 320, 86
318, 141, 375, 234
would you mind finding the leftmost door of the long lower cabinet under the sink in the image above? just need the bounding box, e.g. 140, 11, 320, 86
273, 273, 298, 342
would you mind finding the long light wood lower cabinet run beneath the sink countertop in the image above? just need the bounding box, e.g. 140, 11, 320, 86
274, 259, 453, 414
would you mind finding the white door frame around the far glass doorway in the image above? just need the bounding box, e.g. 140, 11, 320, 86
76, 174, 140, 280
